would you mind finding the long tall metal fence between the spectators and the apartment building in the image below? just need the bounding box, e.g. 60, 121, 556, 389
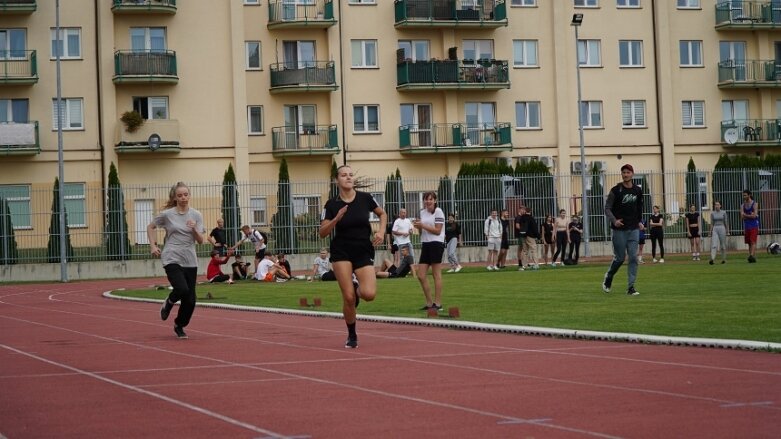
0, 169, 781, 264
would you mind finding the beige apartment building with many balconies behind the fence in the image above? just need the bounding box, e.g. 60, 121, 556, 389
0, 0, 781, 197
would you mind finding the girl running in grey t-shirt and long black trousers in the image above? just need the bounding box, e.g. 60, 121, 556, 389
146, 181, 206, 339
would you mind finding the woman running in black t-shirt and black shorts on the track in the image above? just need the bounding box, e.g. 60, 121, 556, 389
319, 165, 388, 349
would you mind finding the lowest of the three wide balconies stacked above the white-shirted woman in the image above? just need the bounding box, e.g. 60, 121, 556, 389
399, 122, 513, 154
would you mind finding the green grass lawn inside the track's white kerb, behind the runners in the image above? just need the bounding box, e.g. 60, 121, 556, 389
111, 253, 781, 343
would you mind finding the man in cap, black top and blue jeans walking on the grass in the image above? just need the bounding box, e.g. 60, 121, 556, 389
602, 164, 643, 296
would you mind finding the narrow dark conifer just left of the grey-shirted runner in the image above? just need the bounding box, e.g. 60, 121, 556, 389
106, 162, 132, 261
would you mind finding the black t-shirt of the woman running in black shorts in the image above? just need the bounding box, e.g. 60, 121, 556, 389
321, 191, 378, 241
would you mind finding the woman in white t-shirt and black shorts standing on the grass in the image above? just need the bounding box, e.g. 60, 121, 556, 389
413, 191, 444, 311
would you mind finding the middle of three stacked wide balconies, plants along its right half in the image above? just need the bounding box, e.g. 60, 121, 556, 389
396, 59, 510, 91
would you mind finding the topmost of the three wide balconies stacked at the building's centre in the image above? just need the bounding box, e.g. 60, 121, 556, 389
394, 0, 507, 29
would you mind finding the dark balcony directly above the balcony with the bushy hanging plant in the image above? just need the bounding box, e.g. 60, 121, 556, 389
113, 50, 179, 84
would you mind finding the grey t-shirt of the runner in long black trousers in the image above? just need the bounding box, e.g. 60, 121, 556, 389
152, 207, 206, 267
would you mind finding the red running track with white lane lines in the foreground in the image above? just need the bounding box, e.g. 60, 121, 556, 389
0, 279, 781, 439
